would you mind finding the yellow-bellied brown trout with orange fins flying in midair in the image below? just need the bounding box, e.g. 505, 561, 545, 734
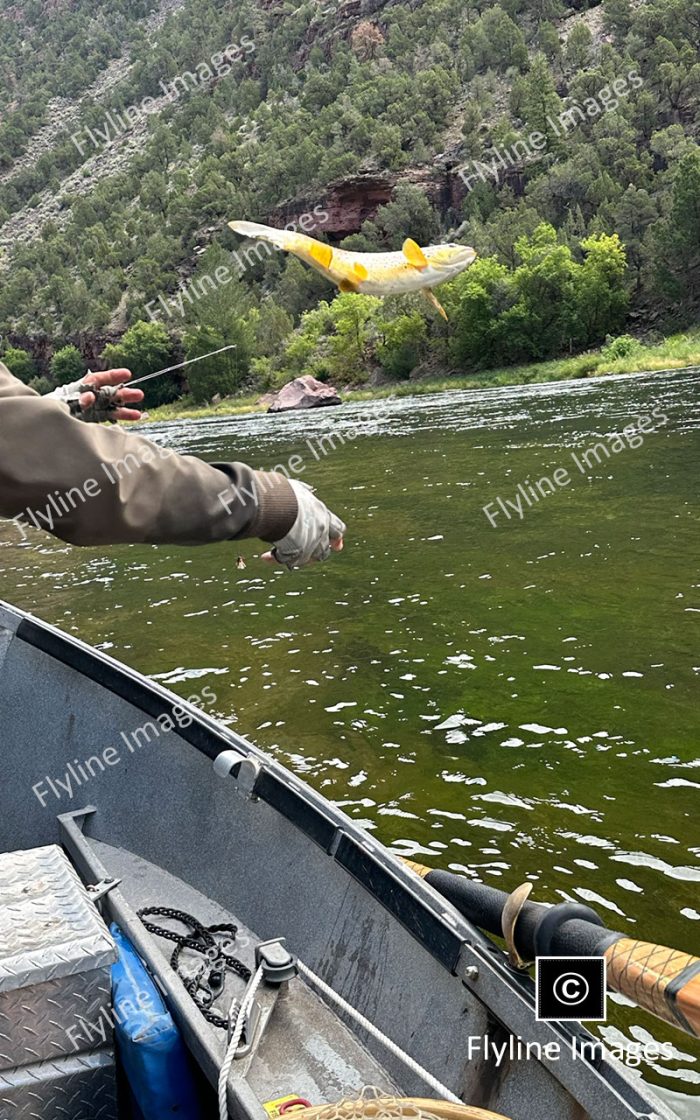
228, 222, 476, 319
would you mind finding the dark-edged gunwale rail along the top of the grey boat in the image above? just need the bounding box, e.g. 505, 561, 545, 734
0, 599, 676, 1118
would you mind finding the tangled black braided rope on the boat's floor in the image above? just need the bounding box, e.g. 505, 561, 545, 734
138, 906, 252, 1030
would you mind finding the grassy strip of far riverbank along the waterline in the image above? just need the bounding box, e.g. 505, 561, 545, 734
144, 329, 700, 421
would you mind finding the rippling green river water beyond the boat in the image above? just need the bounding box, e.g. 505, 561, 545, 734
0, 370, 700, 1117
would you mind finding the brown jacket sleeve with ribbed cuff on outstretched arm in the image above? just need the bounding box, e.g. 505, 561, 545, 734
0, 362, 298, 544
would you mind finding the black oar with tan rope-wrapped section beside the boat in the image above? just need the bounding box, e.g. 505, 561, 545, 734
403, 860, 700, 1038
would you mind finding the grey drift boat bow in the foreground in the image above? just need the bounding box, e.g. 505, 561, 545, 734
0, 605, 689, 1120
